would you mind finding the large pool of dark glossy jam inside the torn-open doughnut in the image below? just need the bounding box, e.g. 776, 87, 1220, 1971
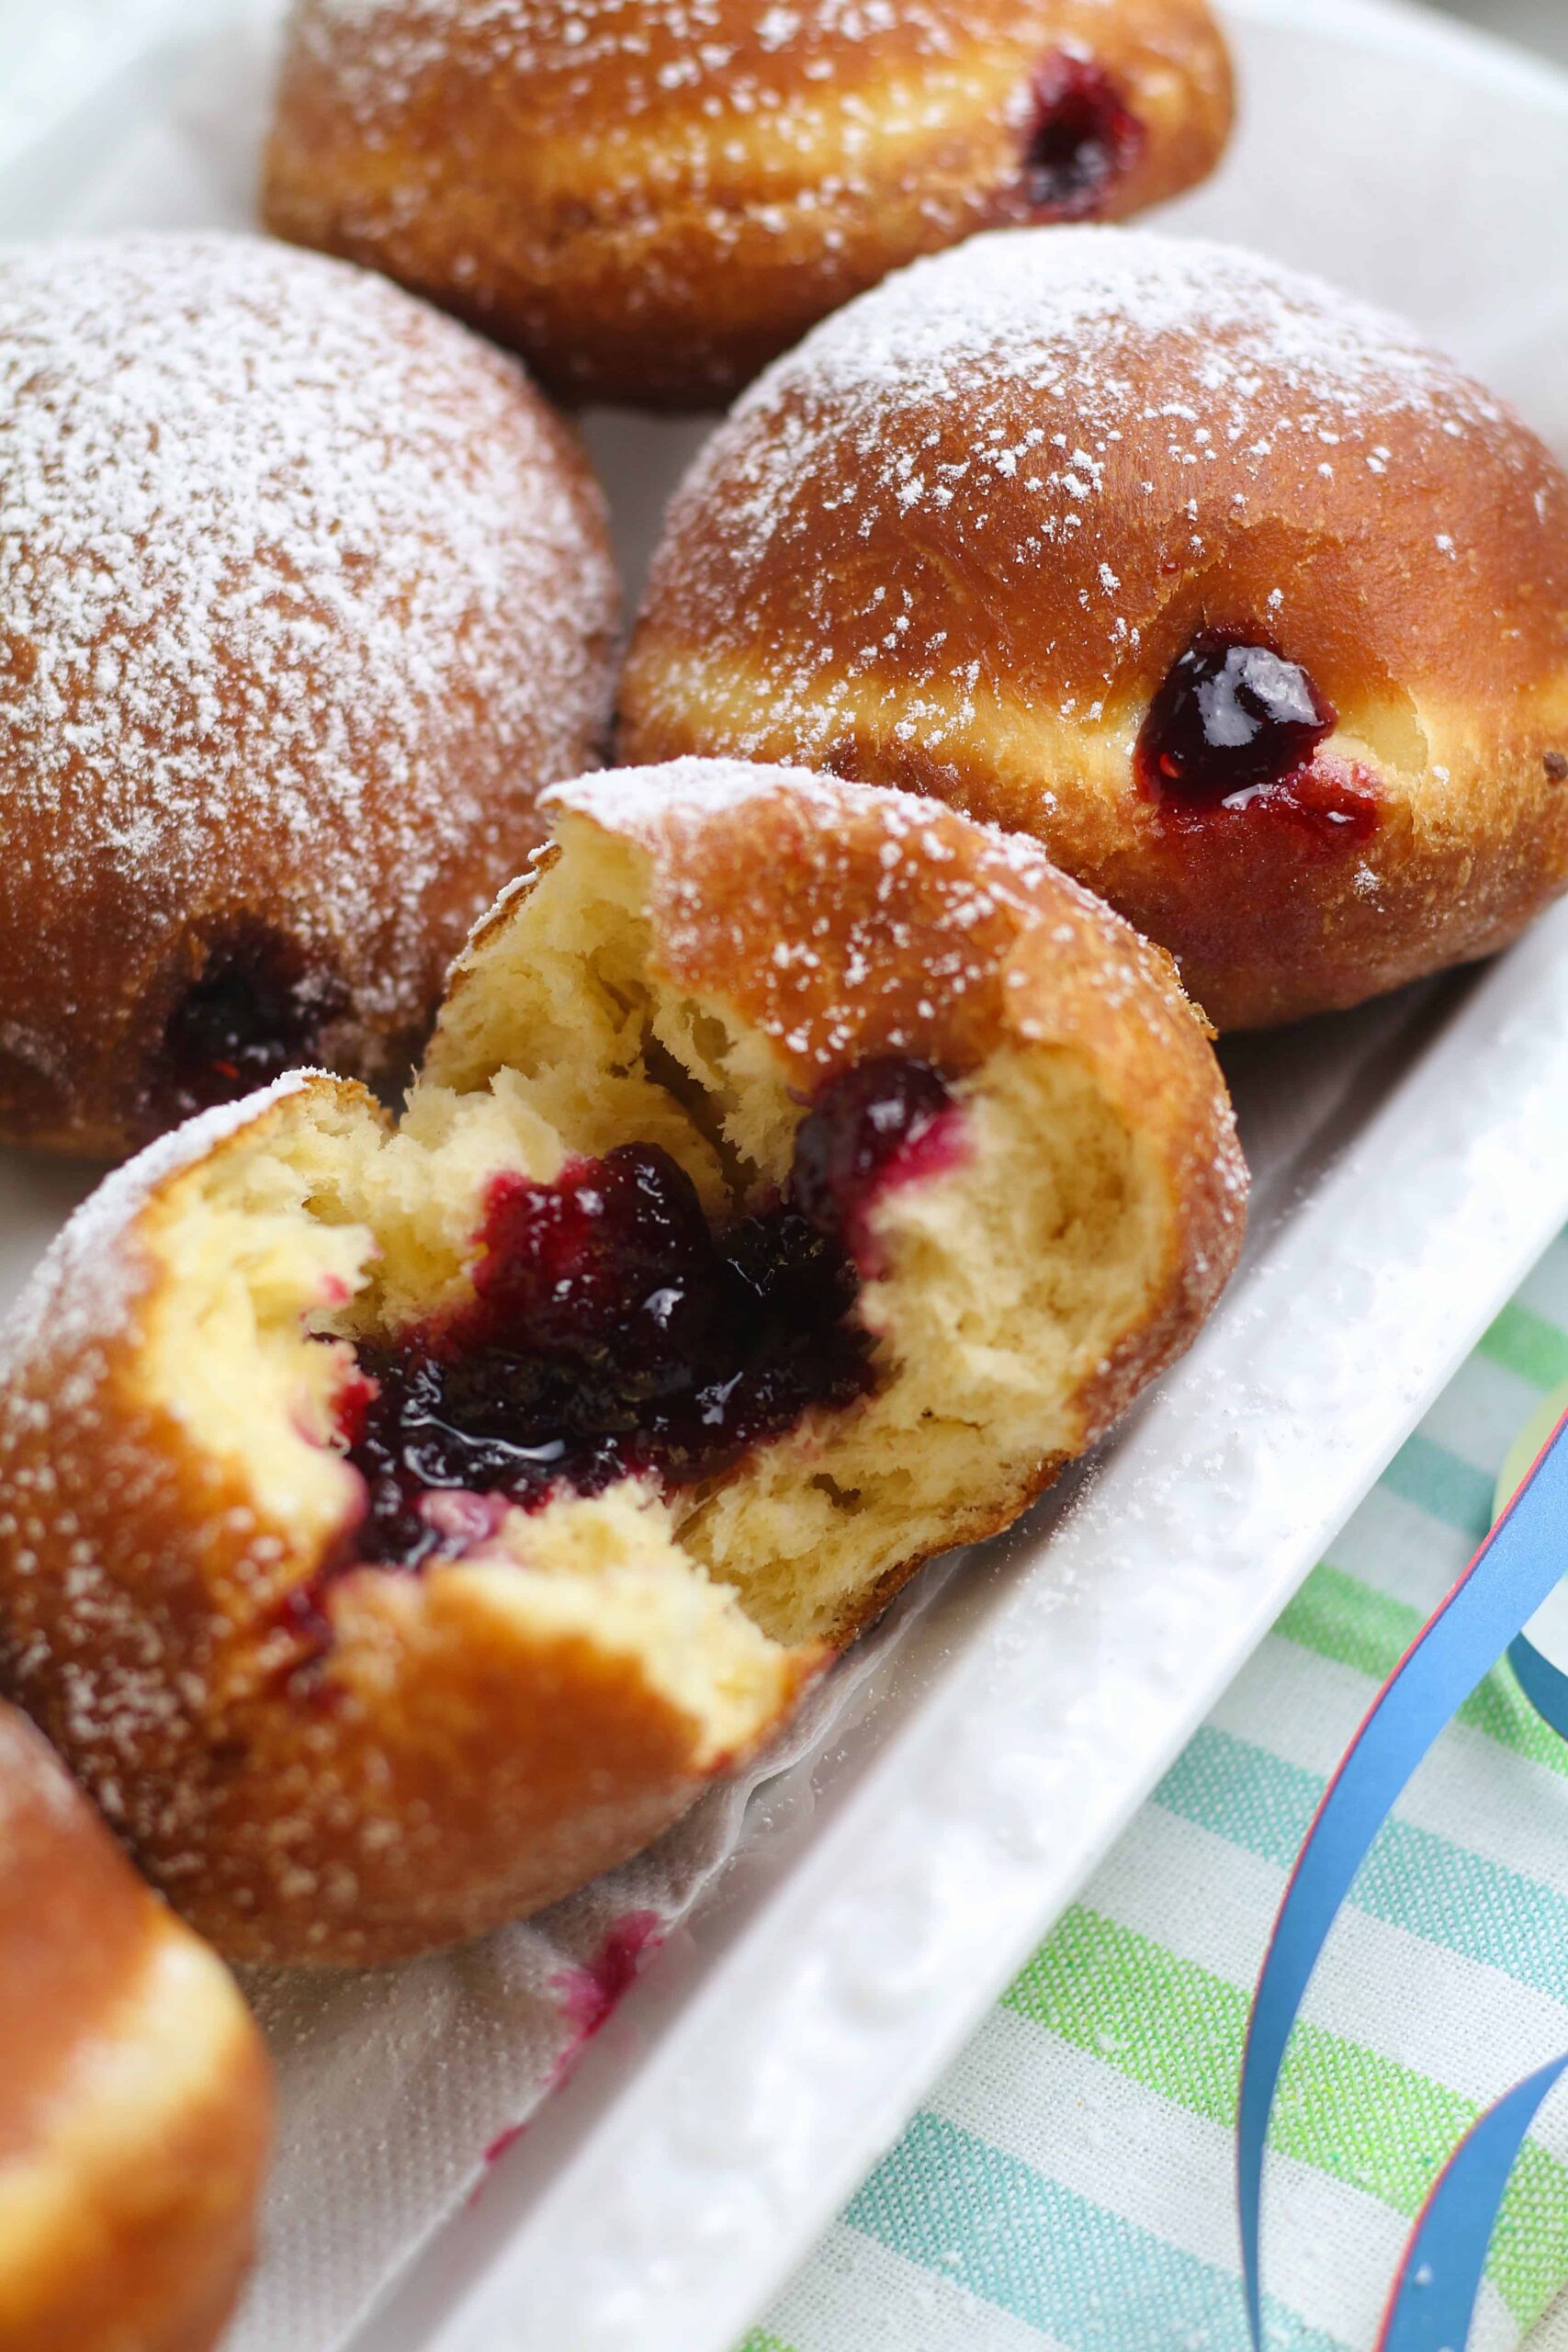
341, 1061, 957, 1566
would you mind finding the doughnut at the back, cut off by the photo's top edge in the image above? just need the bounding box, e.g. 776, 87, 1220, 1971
265, 0, 1232, 409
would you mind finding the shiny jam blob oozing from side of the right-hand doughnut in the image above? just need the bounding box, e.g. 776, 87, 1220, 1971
1135, 630, 1380, 842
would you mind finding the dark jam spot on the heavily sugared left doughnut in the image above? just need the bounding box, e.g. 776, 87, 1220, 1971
151, 932, 341, 1125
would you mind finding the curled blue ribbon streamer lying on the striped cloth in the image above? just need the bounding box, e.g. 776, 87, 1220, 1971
1236, 1414, 1568, 2352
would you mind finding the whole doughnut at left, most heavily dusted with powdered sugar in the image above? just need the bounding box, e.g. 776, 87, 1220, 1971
0, 235, 616, 1155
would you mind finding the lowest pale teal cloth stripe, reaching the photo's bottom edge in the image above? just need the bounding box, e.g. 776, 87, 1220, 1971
844, 2112, 1345, 2352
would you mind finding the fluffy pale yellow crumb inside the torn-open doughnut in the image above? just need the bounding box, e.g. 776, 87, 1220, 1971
146, 816, 1170, 1702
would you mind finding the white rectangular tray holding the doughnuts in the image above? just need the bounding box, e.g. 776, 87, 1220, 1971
0, 0, 1568, 2352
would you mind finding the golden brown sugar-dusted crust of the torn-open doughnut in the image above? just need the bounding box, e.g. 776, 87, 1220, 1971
0, 772, 1244, 1962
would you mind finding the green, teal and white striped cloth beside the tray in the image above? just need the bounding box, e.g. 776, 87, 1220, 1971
743, 1235, 1568, 2352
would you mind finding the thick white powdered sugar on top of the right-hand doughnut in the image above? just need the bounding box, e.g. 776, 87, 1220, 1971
670, 228, 1512, 628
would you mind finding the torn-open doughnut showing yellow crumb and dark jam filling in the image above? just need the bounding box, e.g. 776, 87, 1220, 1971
0, 762, 1246, 1962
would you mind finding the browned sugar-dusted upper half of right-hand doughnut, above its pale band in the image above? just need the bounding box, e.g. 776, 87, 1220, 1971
630, 228, 1568, 724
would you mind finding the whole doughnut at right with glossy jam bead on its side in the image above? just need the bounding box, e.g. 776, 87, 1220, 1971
621, 228, 1568, 1028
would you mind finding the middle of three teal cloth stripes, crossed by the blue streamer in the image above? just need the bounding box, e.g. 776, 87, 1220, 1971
1155, 1724, 1568, 2002
